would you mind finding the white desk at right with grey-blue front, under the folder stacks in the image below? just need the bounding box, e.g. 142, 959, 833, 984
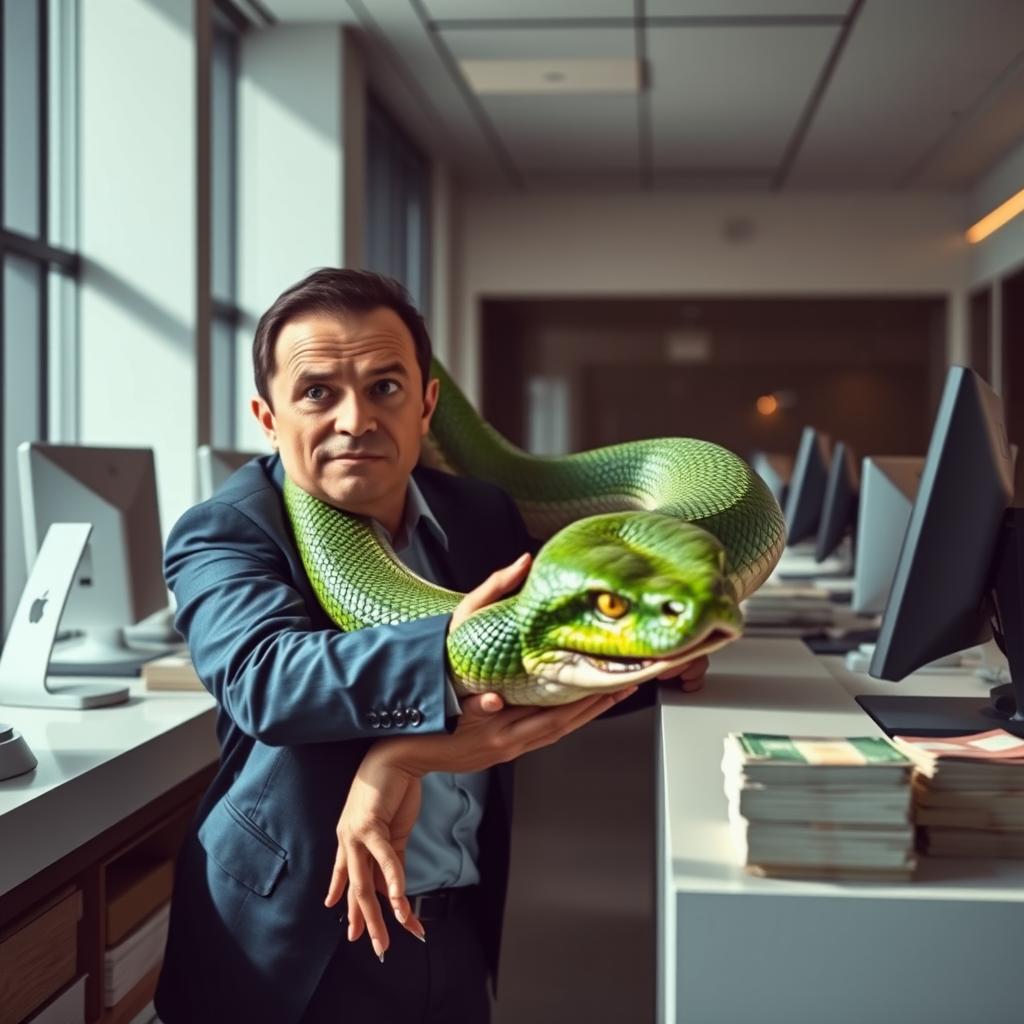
657, 639, 1024, 1024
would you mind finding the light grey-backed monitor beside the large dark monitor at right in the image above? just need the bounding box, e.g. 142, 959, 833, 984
850, 456, 925, 615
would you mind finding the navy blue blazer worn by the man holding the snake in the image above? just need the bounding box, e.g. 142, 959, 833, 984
156, 456, 649, 1024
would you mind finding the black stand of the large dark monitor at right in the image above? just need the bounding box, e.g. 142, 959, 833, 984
857, 508, 1024, 736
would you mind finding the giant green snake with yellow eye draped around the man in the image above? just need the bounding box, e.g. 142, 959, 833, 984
285, 360, 783, 705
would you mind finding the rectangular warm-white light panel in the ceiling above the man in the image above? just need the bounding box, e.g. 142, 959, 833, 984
460, 57, 641, 95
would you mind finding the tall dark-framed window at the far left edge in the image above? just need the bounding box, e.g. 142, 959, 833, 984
0, 0, 79, 636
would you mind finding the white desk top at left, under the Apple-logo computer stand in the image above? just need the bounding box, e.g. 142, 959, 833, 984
0, 677, 218, 896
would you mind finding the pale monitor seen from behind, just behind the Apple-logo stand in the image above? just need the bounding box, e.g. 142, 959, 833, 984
17, 441, 167, 676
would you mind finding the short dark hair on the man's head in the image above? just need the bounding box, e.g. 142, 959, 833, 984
253, 266, 431, 408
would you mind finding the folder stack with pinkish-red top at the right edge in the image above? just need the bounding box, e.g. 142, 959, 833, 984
895, 729, 1024, 857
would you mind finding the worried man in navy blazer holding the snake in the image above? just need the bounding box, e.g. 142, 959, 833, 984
157, 269, 702, 1024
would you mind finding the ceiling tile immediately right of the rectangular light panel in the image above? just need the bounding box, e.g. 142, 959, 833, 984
647, 27, 839, 170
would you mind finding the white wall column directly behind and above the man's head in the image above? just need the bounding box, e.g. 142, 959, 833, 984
236, 25, 366, 451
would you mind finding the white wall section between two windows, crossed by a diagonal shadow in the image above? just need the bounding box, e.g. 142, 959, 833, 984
78, 0, 197, 536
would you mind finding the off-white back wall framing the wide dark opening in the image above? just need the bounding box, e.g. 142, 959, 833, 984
453, 193, 968, 401
